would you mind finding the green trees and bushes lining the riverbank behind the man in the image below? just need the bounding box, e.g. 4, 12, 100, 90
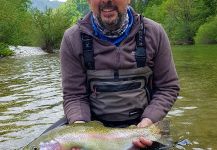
0, 0, 217, 52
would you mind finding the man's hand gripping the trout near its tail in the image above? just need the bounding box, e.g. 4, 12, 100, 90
133, 118, 153, 148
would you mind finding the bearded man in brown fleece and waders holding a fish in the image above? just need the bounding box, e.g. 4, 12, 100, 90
61, 0, 179, 149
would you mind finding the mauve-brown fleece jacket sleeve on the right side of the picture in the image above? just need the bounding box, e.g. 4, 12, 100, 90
142, 25, 179, 122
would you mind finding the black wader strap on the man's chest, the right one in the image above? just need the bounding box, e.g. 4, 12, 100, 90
135, 15, 146, 68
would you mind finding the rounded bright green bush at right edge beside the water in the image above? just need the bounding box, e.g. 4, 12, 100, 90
195, 16, 217, 44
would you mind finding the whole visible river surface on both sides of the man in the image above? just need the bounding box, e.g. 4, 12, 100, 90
0, 45, 217, 150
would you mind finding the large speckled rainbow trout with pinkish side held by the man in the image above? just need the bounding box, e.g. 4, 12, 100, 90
24, 121, 169, 150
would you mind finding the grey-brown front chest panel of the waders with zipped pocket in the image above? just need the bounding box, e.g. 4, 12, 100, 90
88, 67, 152, 121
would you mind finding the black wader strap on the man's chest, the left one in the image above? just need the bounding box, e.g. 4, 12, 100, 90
81, 33, 95, 70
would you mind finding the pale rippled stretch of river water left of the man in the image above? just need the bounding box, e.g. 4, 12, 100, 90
0, 55, 63, 150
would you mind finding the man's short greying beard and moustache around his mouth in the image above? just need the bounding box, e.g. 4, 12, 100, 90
96, 1, 127, 31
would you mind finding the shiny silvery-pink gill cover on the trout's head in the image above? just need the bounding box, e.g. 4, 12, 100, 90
39, 140, 61, 150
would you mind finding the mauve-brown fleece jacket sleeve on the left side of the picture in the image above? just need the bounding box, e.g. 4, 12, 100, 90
60, 30, 90, 123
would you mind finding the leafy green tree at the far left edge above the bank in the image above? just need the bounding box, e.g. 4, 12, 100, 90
0, 0, 31, 45
